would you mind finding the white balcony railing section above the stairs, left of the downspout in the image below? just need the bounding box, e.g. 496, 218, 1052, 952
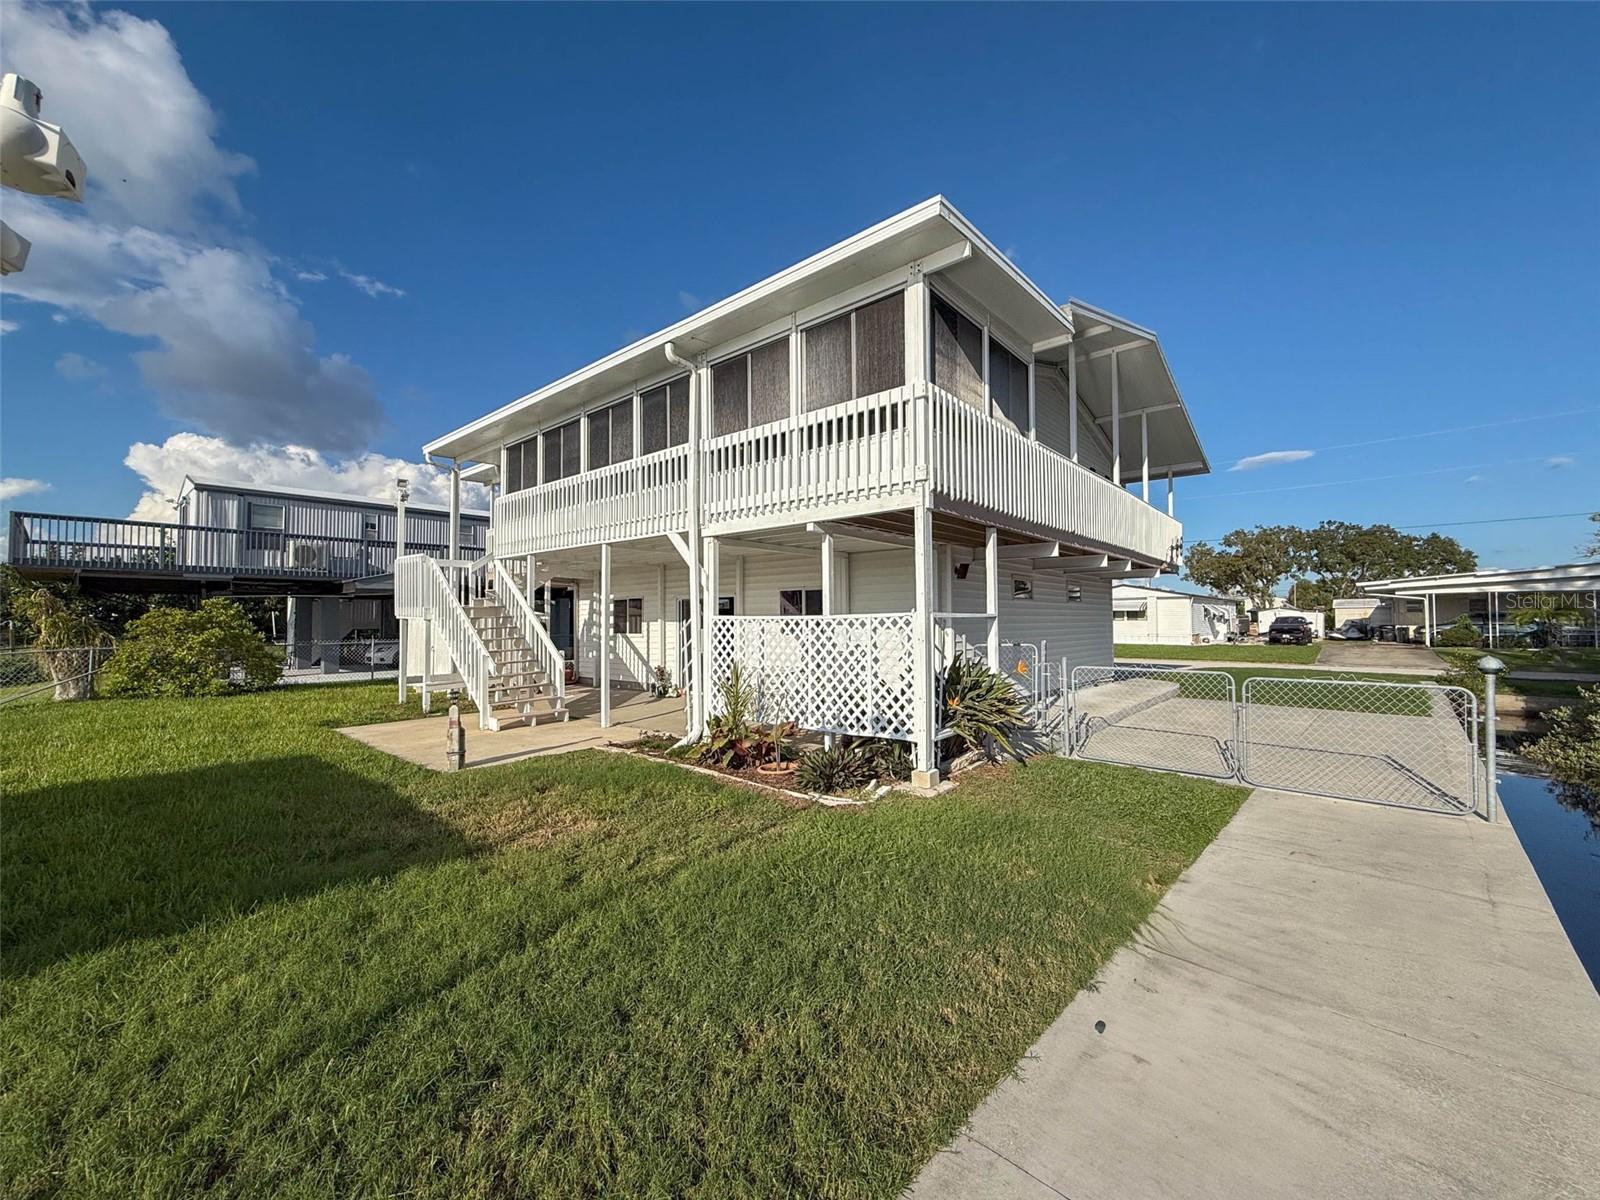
494, 446, 690, 558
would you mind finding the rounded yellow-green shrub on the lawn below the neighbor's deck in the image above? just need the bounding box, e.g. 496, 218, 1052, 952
101, 598, 283, 696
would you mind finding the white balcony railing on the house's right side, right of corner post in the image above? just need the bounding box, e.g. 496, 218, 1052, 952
928, 387, 1182, 563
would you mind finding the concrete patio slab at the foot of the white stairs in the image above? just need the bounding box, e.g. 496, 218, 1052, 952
339, 688, 685, 771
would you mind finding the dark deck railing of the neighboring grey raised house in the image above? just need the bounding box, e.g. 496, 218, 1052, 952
6, 512, 478, 579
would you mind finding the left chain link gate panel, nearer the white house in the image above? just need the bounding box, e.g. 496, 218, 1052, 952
1066, 666, 1238, 779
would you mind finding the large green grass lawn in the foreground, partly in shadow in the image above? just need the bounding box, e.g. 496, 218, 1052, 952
0, 685, 1245, 1198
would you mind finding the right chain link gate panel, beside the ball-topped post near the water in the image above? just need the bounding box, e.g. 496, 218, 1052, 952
1238, 675, 1478, 813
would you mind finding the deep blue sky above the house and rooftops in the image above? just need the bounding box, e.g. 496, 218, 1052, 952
0, 5, 1600, 565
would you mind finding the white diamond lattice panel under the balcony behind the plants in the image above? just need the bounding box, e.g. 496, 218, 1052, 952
710, 613, 917, 741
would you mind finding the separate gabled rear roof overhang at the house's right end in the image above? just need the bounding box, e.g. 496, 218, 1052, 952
1034, 299, 1211, 480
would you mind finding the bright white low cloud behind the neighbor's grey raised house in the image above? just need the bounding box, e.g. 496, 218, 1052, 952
123, 434, 488, 522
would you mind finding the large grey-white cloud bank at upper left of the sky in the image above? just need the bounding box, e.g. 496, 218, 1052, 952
5, 5, 387, 453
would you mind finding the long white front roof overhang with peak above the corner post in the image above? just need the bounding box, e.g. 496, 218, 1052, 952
422, 195, 1072, 461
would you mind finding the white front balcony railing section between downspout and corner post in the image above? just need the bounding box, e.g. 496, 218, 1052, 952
701, 387, 926, 531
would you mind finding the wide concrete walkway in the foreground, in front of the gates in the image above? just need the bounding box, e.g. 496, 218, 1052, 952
910, 790, 1600, 1200
